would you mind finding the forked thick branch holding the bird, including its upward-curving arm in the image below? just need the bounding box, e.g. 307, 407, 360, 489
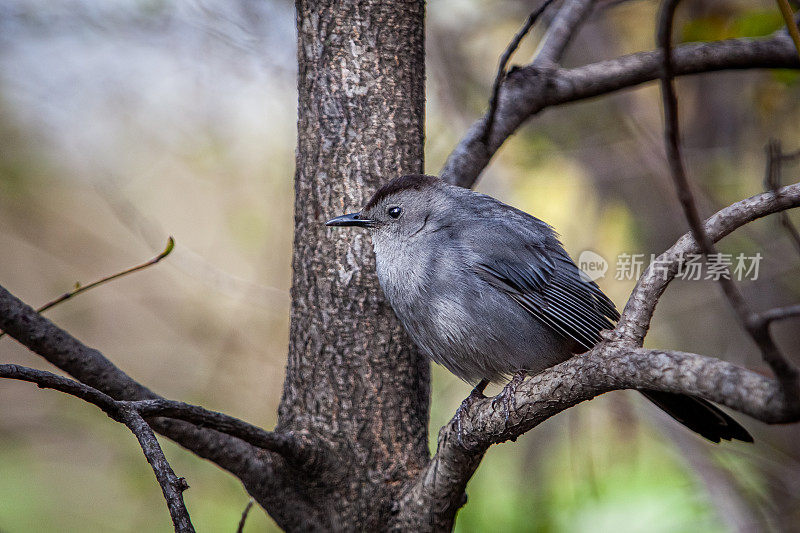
397, 183, 800, 529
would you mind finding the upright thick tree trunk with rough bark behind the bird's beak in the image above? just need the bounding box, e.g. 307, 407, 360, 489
256, 0, 429, 530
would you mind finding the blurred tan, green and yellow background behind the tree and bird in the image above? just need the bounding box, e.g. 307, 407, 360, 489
0, 0, 800, 533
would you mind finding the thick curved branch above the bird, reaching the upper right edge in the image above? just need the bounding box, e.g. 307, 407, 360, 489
440, 32, 800, 187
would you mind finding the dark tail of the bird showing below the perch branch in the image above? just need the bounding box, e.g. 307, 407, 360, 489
639, 390, 753, 442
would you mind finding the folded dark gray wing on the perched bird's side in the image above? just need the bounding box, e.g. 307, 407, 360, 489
473, 215, 619, 351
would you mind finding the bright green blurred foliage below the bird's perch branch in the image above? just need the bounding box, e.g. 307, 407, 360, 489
456, 414, 725, 533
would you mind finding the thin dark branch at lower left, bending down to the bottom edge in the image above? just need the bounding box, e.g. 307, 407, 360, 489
0, 365, 194, 533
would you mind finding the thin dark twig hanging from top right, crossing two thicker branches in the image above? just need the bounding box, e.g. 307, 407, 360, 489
657, 0, 800, 403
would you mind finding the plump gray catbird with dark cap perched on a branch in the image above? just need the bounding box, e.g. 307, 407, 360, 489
327, 175, 753, 442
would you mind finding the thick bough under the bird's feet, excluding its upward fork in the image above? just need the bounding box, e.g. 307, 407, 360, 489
397, 343, 800, 530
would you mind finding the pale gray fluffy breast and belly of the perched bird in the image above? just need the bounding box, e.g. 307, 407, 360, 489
373, 228, 570, 383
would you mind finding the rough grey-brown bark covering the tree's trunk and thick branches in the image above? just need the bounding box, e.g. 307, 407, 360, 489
0, 0, 800, 531
